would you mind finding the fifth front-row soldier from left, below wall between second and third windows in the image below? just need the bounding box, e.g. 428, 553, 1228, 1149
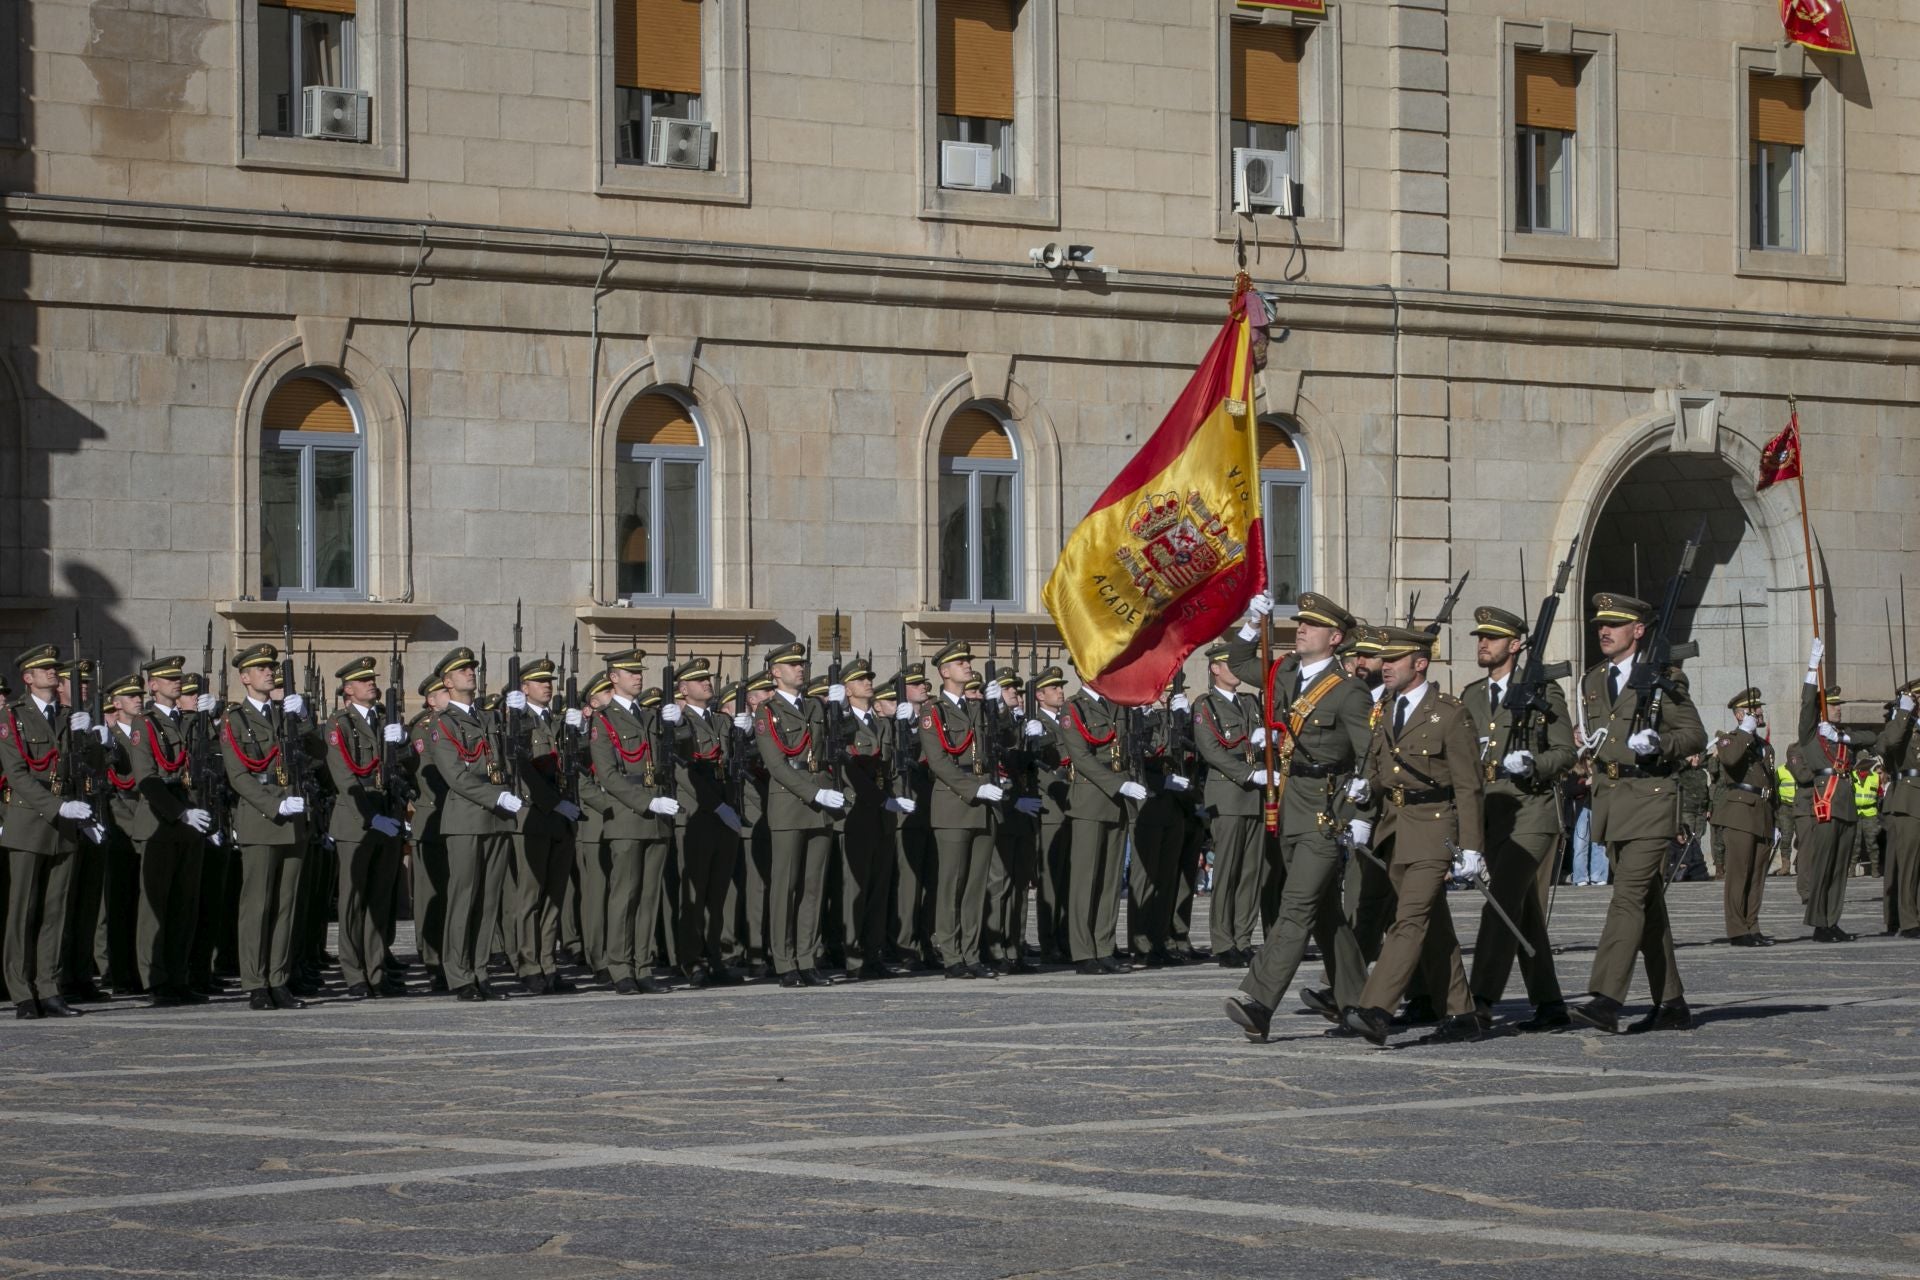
755, 645, 847, 986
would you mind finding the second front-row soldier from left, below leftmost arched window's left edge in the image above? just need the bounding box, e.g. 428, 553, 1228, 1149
221, 643, 307, 1009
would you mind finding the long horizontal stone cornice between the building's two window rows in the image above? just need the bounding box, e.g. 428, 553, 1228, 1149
0, 192, 1920, 365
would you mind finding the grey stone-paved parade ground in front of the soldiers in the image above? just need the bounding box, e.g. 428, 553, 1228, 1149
0, 879, 1920, 1280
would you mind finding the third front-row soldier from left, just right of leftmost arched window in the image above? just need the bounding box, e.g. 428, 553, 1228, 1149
426, 645, 526, 1002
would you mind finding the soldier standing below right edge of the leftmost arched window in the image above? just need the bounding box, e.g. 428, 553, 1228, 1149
326, 656, 407, 1000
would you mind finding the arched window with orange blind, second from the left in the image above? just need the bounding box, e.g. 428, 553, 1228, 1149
614, 391, 708, 604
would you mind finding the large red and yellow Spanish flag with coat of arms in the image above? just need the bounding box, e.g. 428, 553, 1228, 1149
1041, 278, 1267, 706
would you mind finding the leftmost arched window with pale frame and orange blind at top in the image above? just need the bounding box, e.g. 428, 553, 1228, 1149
259, 368, 367, 601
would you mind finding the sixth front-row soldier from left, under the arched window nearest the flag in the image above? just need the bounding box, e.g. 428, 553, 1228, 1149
920, 641, 1006, 979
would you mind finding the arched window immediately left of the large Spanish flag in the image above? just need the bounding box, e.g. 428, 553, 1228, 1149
939, 403, 1021, 608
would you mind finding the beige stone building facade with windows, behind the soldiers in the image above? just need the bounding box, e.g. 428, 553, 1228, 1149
0, 0, 1920, 723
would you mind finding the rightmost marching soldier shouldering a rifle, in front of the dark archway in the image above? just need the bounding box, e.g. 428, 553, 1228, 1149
1571, 593, 1707, 1031
